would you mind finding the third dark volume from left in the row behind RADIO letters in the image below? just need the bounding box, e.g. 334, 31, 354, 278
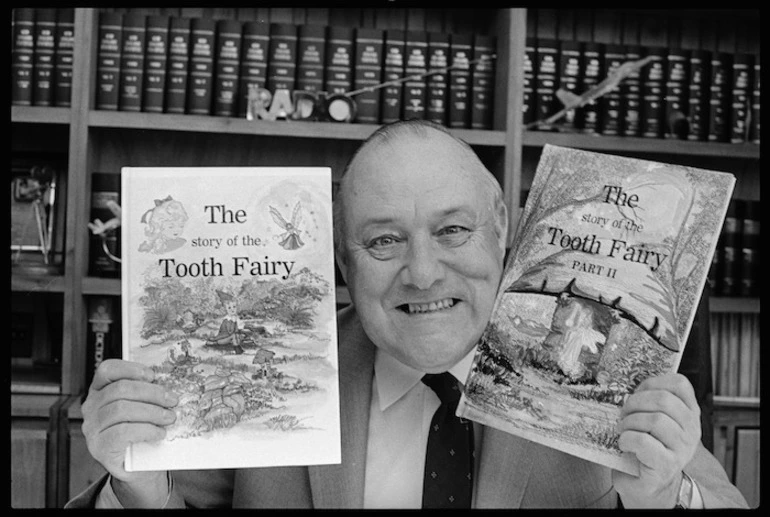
142, 16, 169, 113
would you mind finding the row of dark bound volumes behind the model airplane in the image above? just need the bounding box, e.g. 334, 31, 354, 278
523, 38, 760, 144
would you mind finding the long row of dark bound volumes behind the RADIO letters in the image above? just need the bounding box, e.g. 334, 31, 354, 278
96, 12, 495, 129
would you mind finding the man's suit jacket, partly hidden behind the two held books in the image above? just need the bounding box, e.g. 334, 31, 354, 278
67, 307, 746, 508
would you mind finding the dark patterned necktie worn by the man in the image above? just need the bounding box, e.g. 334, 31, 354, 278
422, 372, 473, 508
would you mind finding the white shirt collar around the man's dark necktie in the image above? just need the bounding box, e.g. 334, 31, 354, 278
374, 346, 476, 411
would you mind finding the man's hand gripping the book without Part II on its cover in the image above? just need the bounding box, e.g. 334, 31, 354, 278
82, 359, 178, 507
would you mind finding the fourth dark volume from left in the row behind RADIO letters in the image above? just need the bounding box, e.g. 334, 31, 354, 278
165, 16, 190, 113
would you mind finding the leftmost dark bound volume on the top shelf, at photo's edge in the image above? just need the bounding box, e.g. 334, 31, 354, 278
11, 7, 35, 106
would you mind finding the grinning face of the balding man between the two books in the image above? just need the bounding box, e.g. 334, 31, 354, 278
340, 133, 507, 373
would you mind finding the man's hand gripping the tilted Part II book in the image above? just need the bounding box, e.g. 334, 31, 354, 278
612, 374, 701, 508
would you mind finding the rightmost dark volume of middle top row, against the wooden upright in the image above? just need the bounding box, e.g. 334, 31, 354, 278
471, 34, 495, 129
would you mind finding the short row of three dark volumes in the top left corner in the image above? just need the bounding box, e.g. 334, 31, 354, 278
11, 7, 75, 107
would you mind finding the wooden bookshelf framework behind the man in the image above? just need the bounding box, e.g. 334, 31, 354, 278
11, 8, 759, 506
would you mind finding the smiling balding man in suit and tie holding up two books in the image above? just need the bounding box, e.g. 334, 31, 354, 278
70, 121, 746, 508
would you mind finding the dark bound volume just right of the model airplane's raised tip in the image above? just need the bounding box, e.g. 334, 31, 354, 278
663, 48, 690, 140
